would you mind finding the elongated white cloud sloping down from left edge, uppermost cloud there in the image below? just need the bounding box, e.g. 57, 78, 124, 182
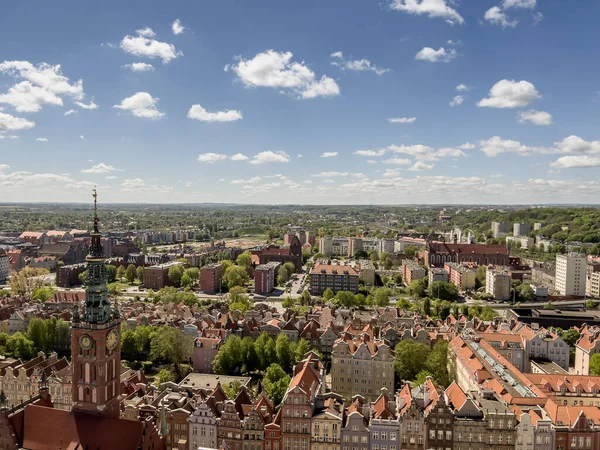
0, 61, 84, 99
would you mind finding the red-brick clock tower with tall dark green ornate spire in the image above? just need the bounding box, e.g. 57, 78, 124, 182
71, 189, 121, 418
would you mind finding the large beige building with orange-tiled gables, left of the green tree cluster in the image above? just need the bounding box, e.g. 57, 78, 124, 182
331, 333, 394, 401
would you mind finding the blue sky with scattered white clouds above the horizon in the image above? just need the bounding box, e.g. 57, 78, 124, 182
0, 0, 600, 204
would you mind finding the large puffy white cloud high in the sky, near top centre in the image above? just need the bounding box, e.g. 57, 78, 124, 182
226, 50, 340, 99
